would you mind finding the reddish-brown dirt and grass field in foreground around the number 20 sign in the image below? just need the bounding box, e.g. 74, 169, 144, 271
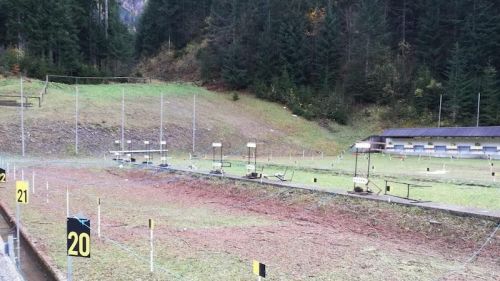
0, 165, 500, 280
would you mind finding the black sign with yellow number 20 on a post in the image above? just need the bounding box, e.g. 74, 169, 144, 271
67, 218, 90, 258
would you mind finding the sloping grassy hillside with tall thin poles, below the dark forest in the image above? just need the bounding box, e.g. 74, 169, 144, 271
0, 79, 378, 155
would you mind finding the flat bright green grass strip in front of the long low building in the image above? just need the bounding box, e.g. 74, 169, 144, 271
167, 155, 500, 211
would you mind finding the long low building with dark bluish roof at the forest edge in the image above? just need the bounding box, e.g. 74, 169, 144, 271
380, 126, 500, 159
